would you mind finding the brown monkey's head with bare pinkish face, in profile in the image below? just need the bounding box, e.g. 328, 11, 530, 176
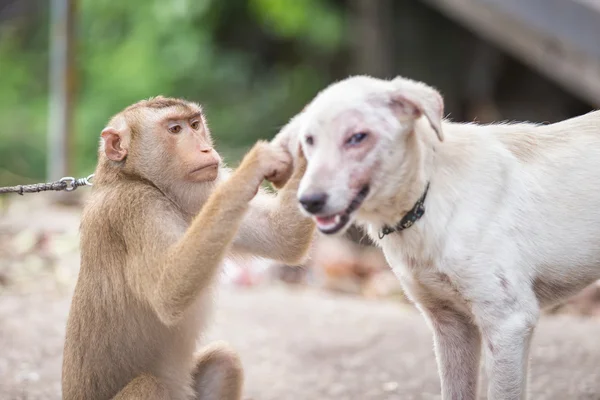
95, 96, 223, 209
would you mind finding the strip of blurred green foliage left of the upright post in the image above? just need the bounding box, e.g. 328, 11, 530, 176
0, 0, 48, 184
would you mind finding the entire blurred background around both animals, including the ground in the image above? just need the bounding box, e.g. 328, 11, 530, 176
0, 0, 600, 399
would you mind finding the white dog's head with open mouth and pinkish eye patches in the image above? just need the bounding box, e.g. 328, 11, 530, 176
282, 76, 443, 234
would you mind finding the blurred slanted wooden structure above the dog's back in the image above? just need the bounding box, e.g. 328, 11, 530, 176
422, 0, 600, 107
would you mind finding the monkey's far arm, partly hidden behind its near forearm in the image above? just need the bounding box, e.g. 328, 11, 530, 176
233, 155, 315, 265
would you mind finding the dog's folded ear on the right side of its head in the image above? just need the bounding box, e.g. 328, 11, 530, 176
390, 77, 444, 142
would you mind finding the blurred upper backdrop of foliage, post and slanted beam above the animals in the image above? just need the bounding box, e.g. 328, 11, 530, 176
0, 0, 600, 185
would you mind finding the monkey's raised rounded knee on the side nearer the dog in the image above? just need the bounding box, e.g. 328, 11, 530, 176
192, 342, 244, 400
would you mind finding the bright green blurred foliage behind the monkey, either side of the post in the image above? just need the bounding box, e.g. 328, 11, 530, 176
0, 0, 344, 185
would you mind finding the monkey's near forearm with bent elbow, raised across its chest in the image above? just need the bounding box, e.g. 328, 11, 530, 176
128, 147, 264, 325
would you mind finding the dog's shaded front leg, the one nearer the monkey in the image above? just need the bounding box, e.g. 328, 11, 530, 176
422, 305, 481, 400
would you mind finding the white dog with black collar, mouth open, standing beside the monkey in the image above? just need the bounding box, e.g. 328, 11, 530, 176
273, 76, 600, 400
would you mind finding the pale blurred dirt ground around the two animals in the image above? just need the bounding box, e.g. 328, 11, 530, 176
0, 198, 600, 400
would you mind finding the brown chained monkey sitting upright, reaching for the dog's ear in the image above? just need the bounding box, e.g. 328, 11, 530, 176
62, 97, 314, 400
